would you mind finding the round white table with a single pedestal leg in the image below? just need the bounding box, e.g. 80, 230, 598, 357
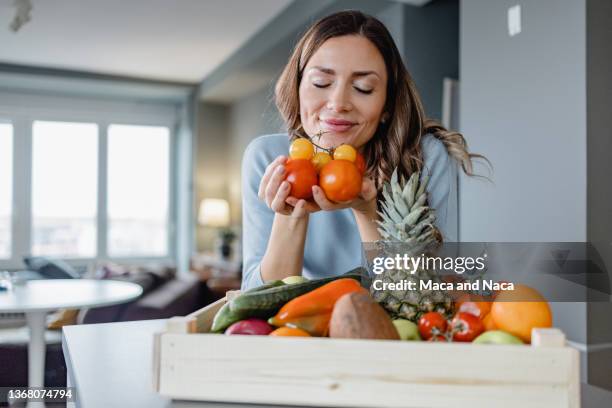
0, 279, 142, 387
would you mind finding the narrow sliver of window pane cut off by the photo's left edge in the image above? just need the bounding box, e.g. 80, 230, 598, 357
0, 123, 13, 259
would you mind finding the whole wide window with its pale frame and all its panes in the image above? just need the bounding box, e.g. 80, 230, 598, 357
0, 91, 184, 271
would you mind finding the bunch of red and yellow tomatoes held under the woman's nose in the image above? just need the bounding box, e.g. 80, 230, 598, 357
285, 138, 365, 202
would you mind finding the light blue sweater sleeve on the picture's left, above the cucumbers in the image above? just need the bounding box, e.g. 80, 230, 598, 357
242, 138, 274, 290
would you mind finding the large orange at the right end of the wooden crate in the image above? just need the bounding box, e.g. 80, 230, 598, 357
491, 284, 552, 343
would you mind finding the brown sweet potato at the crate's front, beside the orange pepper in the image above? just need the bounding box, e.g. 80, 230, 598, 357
329, 292, 399, 340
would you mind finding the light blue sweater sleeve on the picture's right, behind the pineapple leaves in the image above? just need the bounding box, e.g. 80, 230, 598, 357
422, 135, 457, 242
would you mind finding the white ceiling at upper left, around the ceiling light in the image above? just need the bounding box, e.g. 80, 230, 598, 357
0, 0, 291, 83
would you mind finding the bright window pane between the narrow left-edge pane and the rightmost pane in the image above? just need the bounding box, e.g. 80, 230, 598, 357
32, 121, 98, 258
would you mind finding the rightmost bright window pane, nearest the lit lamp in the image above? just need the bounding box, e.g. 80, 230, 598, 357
107, 125, 170, 257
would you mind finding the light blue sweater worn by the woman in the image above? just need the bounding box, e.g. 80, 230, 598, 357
242, 134, 457, 290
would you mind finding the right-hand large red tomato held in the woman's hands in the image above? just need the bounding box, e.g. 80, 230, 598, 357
319, 160, 362, 202
